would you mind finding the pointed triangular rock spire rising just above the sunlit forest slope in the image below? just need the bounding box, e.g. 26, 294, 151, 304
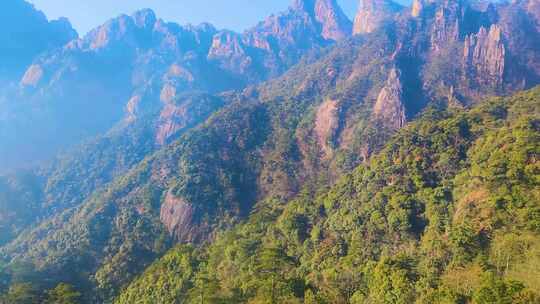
373, 68, 407, 129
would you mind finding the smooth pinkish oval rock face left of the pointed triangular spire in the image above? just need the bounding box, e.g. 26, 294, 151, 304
314, 99, 339, 157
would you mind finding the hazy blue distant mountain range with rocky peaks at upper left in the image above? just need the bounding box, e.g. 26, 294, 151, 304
0, 0, 351, 172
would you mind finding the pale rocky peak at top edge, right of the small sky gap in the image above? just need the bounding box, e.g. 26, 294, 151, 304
353, 0, 402, 34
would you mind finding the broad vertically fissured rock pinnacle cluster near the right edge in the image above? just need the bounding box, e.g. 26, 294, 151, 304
463, 24, 506, 88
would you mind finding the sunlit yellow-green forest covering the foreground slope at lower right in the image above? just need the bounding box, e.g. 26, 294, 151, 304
0, 88, 540, 303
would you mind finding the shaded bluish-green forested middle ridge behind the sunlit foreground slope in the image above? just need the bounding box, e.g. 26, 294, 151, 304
0, 33, 403, 301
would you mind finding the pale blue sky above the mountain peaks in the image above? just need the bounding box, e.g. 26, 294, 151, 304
28, 0, 412, 34
